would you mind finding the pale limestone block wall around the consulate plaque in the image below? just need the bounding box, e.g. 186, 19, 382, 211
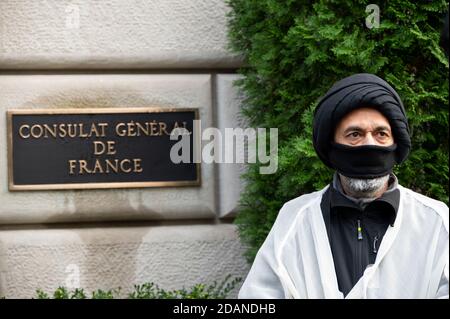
0, 0, 248, 298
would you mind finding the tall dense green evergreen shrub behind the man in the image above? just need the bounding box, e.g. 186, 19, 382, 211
228, 0, 449, 261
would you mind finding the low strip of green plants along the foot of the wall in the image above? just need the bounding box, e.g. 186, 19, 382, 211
36, 276, 242, 299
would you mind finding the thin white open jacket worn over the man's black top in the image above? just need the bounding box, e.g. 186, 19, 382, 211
239, 185, 449, 299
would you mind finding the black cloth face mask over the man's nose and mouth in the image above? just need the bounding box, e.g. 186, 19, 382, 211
329, 142, 397, 179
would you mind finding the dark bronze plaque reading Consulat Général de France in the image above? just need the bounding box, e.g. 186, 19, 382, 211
7, 108, 200, 191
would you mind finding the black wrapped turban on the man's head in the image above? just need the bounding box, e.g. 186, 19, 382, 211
313, 73, 411, 168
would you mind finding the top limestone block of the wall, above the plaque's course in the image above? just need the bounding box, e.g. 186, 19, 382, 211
0, 0, 241, 69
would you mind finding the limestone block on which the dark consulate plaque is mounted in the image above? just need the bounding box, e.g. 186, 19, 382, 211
0, 74, 216, 224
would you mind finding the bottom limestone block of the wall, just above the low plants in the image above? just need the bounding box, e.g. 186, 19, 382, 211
0, 224, 248, 298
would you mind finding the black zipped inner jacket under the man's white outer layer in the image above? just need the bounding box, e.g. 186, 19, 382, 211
320, 181, 400, 296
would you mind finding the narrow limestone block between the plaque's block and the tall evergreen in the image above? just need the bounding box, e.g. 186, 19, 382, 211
216, 74, 248, 217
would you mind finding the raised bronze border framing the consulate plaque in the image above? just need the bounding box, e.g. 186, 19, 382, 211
6, 107, 201, 191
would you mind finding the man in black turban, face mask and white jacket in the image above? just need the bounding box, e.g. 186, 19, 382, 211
239, 74, 449, 299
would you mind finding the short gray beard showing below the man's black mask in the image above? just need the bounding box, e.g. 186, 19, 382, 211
339, 174, 389, 198
